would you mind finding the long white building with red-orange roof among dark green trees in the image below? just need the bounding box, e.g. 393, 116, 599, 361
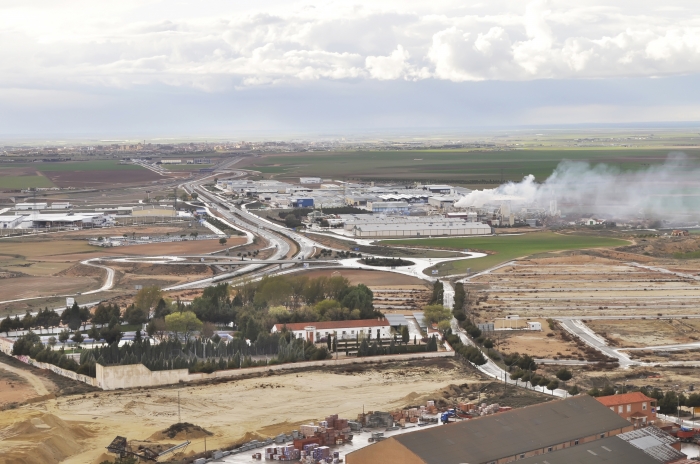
271, 319, 391, 342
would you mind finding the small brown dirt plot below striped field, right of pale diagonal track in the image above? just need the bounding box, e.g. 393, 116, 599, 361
586, 320, 698, 348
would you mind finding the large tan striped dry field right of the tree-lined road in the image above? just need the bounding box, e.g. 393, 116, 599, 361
468, 252, 700, 320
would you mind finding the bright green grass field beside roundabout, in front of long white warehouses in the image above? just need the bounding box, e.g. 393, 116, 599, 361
380, 232, 629, 275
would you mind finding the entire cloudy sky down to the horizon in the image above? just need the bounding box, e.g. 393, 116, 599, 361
0, 0, 700, 138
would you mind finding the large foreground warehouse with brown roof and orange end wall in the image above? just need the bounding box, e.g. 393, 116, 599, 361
346, 395, 644, 464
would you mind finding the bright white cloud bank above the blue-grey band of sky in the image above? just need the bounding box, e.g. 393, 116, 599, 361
0, 0, 700, 91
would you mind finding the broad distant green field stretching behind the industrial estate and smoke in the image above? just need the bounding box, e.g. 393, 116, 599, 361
246, 148, 700, 183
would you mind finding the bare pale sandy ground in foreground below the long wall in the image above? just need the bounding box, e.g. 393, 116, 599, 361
0, 360, 479, 464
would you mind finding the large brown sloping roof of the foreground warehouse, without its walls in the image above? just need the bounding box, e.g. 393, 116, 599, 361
394, 395, 630, 464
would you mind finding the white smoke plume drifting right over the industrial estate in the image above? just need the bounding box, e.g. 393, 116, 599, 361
455, 153, 700, 218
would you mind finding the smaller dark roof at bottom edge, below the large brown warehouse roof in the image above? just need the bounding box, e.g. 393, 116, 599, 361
518, 437, 659, 464
